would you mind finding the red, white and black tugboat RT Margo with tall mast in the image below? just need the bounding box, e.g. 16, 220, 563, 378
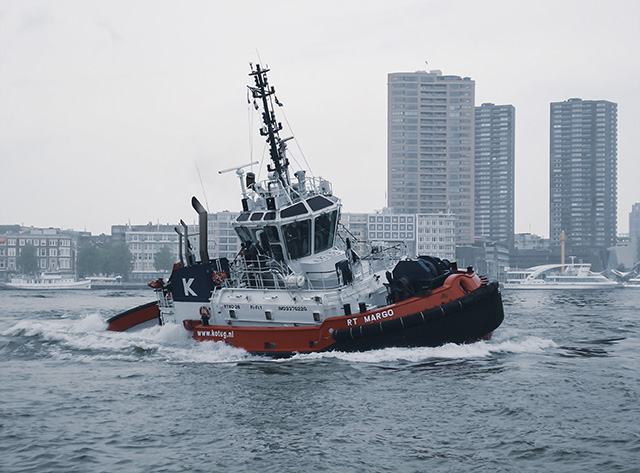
107, 64, 504, 356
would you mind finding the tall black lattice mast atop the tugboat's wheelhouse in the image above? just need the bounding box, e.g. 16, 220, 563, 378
249, 64, 290, 188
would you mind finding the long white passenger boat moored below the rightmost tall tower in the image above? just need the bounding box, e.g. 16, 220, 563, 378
504, 263, 620, 289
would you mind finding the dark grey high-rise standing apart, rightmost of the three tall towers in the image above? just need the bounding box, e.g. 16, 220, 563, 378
549, 98, 618, 271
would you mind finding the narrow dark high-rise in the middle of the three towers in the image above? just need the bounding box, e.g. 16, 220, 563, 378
475, 103, 515, 248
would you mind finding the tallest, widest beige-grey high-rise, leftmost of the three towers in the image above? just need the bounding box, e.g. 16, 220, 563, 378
384, 71, 475, 243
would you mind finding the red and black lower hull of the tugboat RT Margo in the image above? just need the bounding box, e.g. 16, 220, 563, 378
192, 273, 504, 357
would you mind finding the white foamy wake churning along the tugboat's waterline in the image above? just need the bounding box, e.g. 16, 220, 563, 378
0, 313, 557, 364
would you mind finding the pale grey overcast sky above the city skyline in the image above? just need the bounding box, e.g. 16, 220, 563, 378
0, 0, 640, 236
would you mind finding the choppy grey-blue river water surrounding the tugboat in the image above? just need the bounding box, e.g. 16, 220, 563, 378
0, 289, 640, 473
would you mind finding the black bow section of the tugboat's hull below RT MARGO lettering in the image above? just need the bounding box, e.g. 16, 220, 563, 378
328, 282, 504, 352
